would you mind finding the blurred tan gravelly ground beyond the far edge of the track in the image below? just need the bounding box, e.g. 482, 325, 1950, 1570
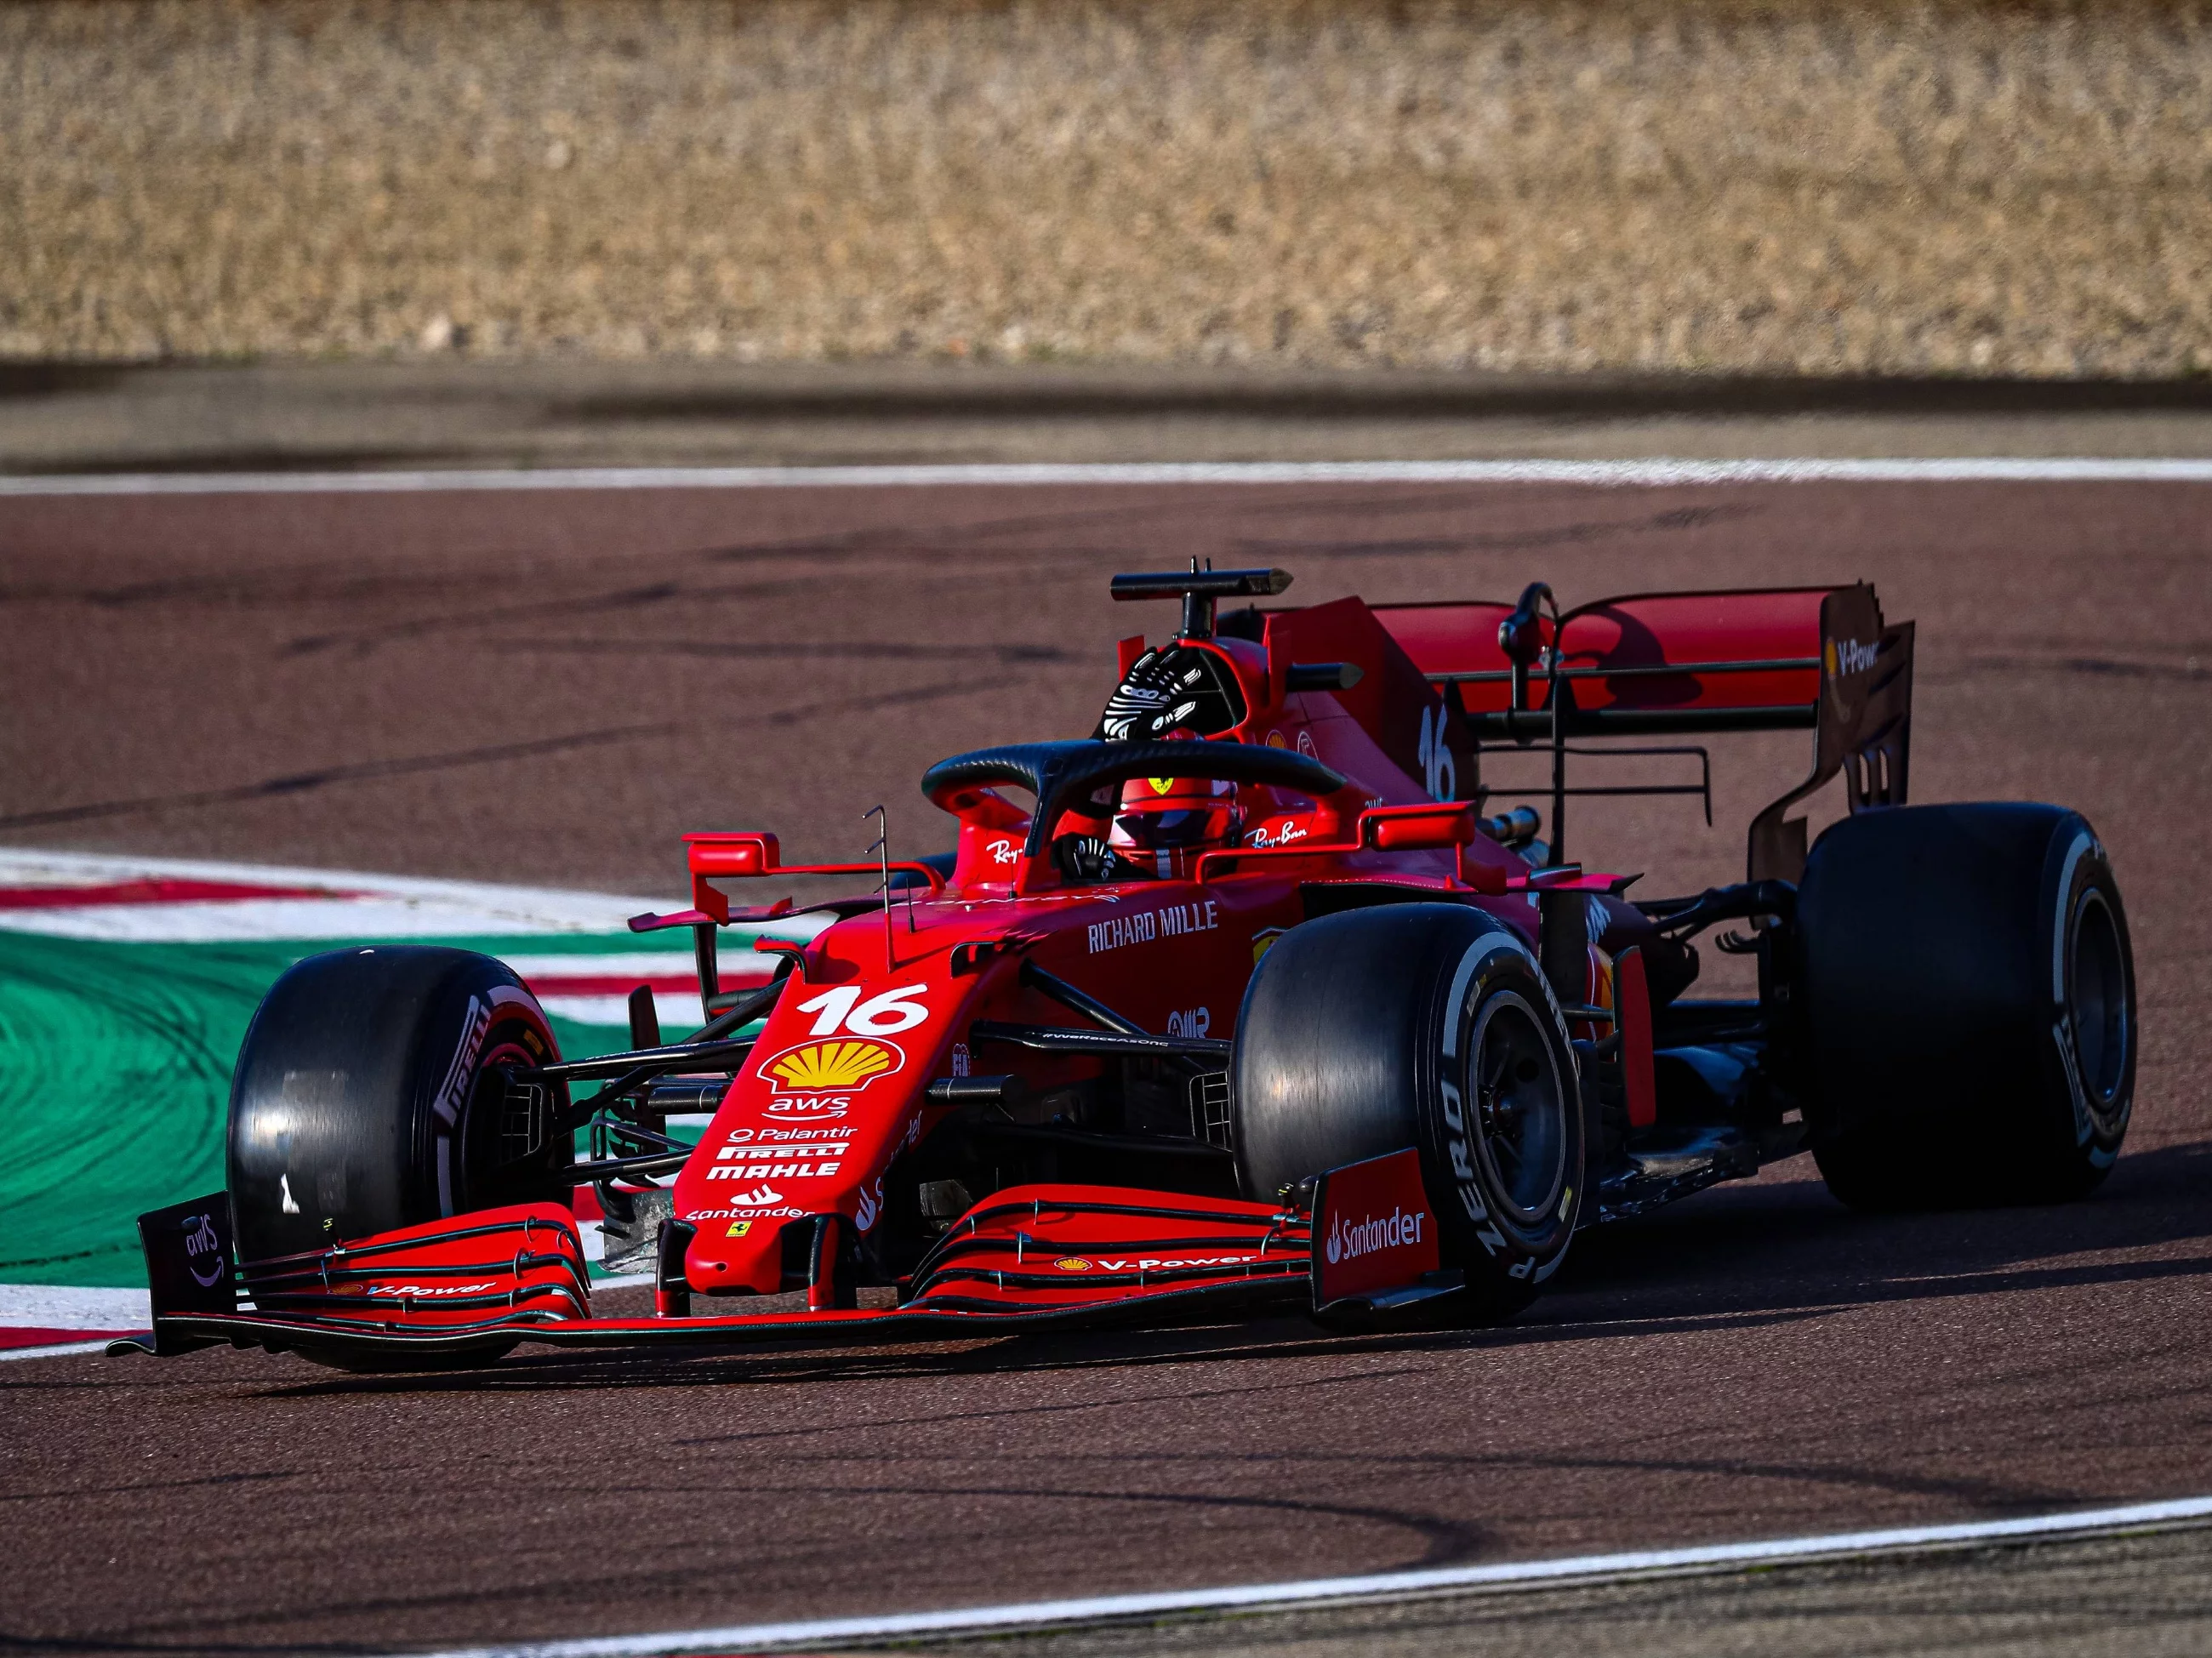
0, 0, 2212, 376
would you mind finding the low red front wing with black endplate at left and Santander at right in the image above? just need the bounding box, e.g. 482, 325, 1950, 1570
111, 1149, 1460, 1364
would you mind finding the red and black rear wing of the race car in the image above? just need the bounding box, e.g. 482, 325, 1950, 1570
1374, 584, 1913, 880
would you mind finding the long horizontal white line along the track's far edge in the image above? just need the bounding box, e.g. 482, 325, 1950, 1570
0, 455, 2212, 495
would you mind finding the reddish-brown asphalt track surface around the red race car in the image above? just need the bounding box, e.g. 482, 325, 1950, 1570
0, 482, 2212, 1651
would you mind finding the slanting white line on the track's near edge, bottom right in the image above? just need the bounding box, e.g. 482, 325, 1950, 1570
407, 1496, 2212, 1658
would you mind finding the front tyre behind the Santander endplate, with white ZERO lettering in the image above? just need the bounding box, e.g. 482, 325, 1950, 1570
1232, 904, 1584, 1319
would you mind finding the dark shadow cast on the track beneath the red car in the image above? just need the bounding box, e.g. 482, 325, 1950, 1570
242, 1143, 2212, 1410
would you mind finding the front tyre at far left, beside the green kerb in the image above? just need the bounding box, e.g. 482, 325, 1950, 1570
228, 946, 575, 1262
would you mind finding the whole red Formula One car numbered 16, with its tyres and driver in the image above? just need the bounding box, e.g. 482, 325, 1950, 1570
129, 570, 2135, 1366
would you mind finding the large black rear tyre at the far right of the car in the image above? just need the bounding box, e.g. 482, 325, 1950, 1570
1799, 802, 2137, 1209
